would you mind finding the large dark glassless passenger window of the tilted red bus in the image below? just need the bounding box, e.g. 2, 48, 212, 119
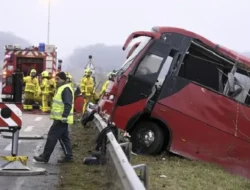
178, 43, 234, 93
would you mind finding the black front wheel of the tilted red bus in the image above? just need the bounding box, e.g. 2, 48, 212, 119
131, 121, 164, 154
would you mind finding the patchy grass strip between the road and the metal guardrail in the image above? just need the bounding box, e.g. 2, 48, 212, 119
58, 125, 108, 190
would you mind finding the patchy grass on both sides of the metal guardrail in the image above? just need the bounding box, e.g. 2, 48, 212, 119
58, 121, 250, 190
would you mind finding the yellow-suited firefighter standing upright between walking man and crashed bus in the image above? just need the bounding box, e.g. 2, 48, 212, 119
80, 69, 95, 114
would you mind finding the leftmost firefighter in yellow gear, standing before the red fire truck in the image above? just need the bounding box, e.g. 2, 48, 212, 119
23, 69, 39, 110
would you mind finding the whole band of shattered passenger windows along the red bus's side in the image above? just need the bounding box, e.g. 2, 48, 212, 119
178, 40, 250, 106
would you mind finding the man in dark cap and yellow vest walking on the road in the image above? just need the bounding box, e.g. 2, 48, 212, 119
34, 72, 74, 163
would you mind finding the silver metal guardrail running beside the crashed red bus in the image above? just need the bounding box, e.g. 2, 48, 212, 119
88, 108, 148, 190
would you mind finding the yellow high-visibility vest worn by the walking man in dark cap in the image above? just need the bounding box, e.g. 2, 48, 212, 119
50, 84, 74, 124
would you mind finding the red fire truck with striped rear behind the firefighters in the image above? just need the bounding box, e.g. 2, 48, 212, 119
2, 45, 61, 101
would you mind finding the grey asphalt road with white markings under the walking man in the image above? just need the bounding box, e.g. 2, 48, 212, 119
0, 114, 62, 190
